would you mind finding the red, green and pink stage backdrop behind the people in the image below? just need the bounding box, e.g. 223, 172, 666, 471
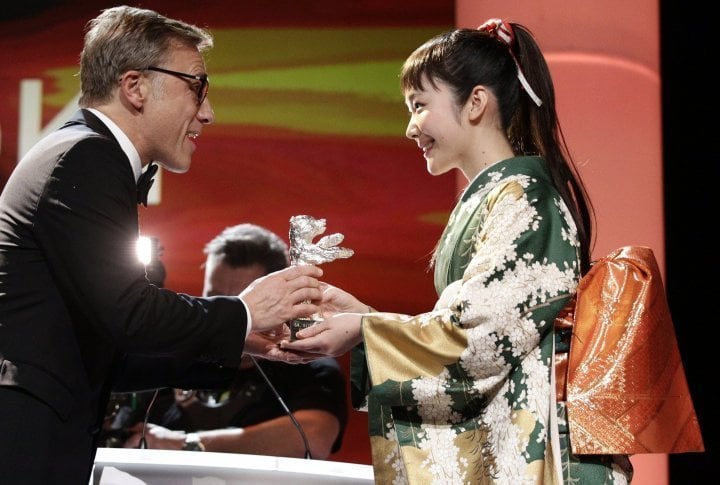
0, 0, 680, 485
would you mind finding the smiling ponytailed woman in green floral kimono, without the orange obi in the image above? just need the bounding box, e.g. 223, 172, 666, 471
283, 19, 632, 485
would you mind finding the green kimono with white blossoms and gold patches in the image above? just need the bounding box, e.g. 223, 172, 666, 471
352, 157, 625, 485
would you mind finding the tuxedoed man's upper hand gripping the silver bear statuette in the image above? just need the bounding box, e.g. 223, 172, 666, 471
240, 265, 323, 332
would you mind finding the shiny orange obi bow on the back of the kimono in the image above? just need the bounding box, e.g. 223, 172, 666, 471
555, 246, 704, 454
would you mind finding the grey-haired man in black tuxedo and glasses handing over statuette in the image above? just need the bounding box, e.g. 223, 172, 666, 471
0, 6, 322, 485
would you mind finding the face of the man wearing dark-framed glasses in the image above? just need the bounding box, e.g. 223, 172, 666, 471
141, 44, 215, 173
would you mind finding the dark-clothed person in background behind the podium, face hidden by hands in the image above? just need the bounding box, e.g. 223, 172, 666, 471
124, 224, 348, 459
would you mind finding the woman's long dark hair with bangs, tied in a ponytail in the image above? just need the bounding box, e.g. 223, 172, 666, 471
400, 23, 594, 274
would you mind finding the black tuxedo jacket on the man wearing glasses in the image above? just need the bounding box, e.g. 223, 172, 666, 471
0, 110, 247, 483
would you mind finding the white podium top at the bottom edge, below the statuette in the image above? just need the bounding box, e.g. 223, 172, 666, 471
90, 448, 374, 485
